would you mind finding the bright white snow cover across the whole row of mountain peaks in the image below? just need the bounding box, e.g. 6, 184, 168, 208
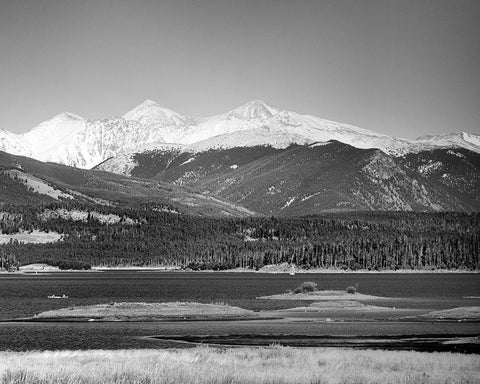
0, 100, 480, 173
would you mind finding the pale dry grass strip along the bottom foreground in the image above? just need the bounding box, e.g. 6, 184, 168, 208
0, 346, 480, 384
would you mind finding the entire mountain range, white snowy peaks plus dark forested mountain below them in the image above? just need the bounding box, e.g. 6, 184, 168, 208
0, 100, 480, 215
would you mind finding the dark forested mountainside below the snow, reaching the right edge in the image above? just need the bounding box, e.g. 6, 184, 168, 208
99, 140, 480, 216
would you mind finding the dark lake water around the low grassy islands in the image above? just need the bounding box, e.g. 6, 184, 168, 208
0, 271, 480, 350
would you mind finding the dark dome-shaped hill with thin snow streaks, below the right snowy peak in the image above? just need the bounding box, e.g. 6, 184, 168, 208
183, 142, 473, 215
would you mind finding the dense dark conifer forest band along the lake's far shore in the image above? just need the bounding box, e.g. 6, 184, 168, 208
0, 203, 480, 270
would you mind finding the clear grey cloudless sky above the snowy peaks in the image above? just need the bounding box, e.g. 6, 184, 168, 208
0, 0, 480, 138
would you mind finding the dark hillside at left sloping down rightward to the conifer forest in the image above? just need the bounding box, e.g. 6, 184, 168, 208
0, 152, 253, 216
